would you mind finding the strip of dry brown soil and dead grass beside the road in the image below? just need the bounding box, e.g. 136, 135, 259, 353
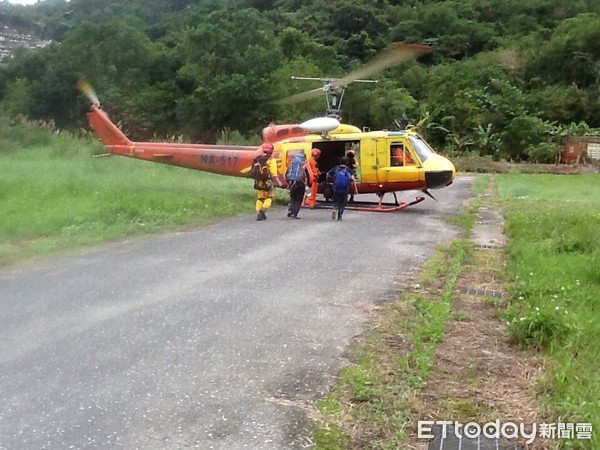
407, 249, 547, 450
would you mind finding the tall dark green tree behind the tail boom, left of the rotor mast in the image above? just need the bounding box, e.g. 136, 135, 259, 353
177, 9, 282, 140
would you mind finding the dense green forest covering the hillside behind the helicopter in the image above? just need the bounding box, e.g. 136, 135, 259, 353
0, 0, 600, 162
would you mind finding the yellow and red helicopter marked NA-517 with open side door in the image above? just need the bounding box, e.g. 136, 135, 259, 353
79, 43, 456, 212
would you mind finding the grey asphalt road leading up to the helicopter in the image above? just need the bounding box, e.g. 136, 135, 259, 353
0, 177, 472, 450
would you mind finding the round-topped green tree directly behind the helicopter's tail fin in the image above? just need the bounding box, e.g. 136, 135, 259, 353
49, 18, 176, 138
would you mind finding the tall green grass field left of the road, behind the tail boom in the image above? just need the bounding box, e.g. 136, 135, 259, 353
0, 126, 255, 265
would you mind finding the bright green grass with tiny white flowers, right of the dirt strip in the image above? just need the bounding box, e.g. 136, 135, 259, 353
496, 174, 600, 448
